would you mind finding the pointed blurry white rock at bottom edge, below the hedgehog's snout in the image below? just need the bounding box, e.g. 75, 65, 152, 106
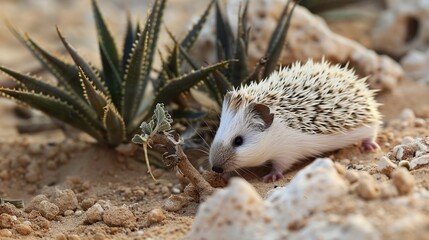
189, 178, 270, 240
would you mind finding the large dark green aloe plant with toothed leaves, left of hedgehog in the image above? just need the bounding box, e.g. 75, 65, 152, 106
0, 0, 229, 146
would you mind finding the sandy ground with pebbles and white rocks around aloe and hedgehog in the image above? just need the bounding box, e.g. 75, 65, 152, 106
0, 0, 429, 240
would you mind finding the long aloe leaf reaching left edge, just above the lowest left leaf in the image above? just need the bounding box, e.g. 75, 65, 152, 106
0, 66, 100, 129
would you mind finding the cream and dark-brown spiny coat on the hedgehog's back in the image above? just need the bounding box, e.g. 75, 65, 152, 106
224, 60, 381, 134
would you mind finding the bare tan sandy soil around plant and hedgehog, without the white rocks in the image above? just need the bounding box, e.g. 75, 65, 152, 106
0, 0, 429, 239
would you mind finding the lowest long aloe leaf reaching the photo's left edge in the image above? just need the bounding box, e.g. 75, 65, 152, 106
0, 88, 104, 142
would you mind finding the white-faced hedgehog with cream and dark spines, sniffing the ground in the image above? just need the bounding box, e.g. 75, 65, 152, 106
209, 60, 381, 182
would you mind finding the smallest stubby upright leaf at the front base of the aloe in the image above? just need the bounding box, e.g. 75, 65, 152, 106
103, 103, 125, 146
